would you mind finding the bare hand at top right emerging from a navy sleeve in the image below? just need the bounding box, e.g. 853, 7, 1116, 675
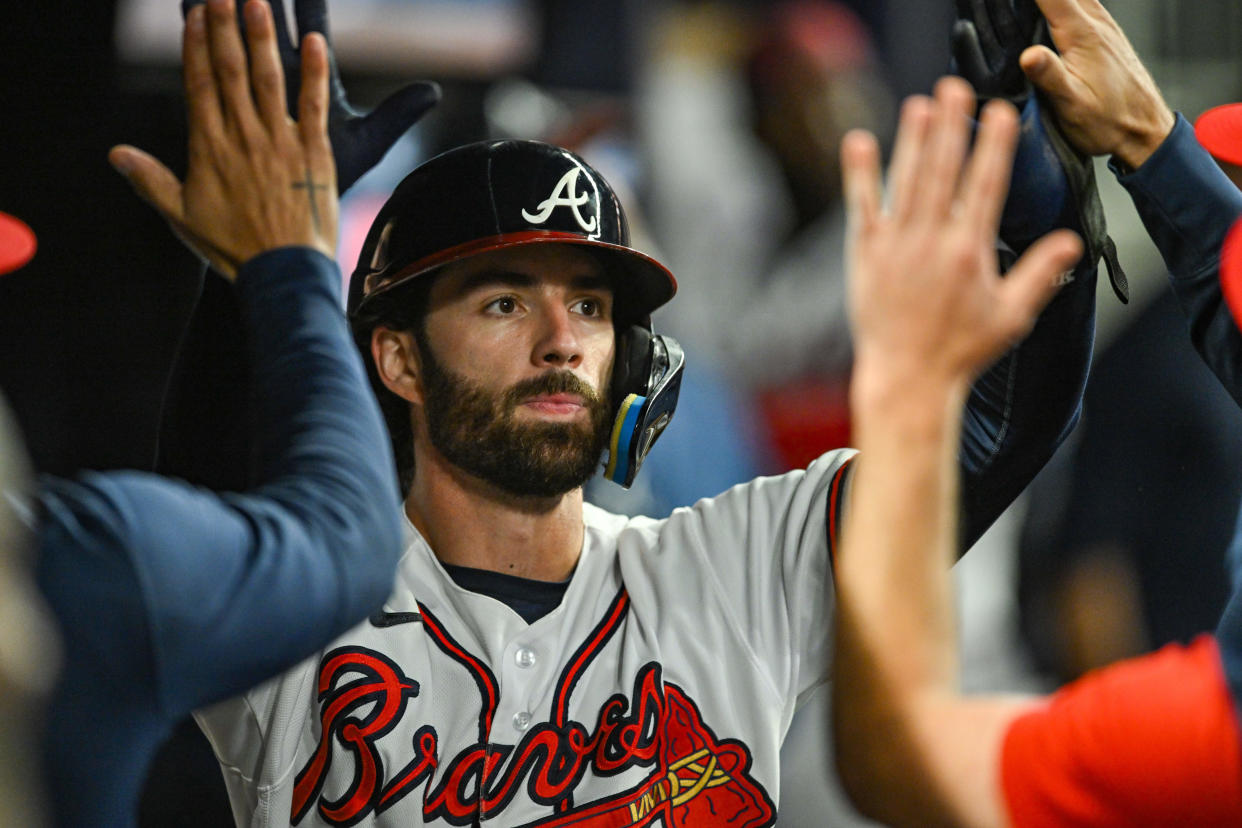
1021, 0, 1175, 168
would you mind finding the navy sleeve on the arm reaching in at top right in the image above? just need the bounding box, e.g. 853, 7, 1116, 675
1113, 114, 1242, 403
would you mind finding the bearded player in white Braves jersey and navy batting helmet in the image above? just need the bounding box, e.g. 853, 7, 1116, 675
196, 11, 1095, 826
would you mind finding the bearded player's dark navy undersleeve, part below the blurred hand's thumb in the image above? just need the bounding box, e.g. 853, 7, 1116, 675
959, 238, 1095, 550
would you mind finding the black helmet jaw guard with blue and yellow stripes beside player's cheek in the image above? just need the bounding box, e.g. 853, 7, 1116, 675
604, 322, 686, 489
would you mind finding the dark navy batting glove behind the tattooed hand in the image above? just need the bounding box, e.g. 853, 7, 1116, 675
181, 0, 440, 192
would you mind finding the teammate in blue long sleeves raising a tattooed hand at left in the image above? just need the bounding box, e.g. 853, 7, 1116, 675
22, 0, 422, 826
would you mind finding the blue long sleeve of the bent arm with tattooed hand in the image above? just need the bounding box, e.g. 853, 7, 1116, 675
39, 248, 401, 715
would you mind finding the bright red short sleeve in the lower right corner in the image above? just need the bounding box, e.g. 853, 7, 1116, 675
1001, 636, 1242, 828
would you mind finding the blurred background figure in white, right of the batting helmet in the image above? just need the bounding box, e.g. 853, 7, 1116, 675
637, 0, 893, 479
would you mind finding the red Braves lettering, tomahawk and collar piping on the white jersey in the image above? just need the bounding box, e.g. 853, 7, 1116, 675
291, 590, 775, 828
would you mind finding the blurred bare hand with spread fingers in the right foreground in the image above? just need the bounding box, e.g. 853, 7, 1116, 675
841, 77, 1082, 395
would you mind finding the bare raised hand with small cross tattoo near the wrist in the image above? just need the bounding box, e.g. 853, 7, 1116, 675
109, 0, 337, 279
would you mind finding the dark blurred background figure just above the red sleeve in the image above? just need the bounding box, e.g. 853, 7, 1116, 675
1018, 292, 1242, 684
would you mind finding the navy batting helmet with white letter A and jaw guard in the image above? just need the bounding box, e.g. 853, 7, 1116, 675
348, 140, 686, 487
